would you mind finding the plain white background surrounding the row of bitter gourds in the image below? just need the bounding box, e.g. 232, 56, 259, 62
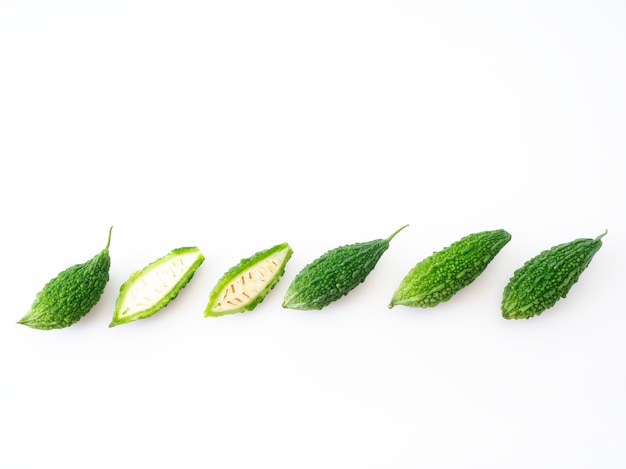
0, 0, 626, 469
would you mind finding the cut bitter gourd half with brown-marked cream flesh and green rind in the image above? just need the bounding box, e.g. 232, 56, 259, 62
204, 243, 293, 317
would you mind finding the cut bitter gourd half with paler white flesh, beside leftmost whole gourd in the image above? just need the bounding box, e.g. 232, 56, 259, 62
109, 247, 204, 327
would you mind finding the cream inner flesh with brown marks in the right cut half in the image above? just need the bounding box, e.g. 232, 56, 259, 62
213, 249, 287, 312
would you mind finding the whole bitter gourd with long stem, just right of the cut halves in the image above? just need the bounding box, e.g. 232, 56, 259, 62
283, 225, 408, 310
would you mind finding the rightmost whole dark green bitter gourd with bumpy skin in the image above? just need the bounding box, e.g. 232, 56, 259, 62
502, 232, 606, 319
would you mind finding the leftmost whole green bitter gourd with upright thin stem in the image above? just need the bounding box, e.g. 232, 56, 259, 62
19, 230, 111, 330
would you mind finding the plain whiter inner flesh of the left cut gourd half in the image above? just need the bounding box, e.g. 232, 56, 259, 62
121, 252, 199, 316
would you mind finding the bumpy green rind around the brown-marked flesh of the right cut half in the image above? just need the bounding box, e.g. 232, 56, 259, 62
204, 243, 293, 317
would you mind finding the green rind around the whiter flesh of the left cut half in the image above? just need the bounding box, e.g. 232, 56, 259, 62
109, 246, 204, 327
